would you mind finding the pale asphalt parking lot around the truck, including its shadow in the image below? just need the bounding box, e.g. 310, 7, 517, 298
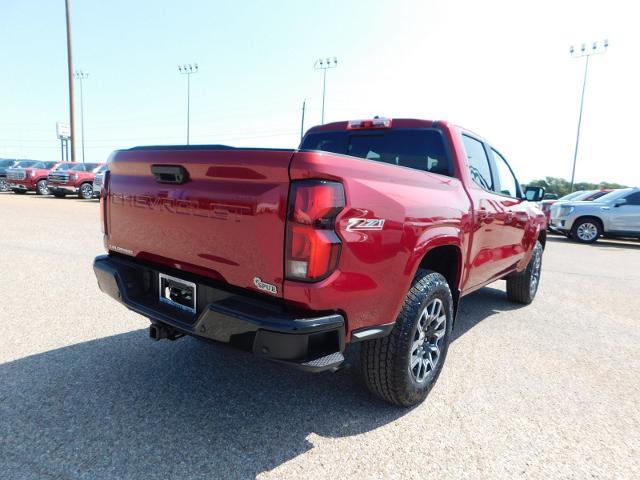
0, 193, 640, 479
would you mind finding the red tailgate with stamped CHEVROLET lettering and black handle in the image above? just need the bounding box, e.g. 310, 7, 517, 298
103, 147, 293, 296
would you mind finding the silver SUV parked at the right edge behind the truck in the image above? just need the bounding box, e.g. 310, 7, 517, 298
550, 188, 640, 243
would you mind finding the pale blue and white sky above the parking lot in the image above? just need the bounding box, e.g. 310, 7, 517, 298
0, 0, 640, 186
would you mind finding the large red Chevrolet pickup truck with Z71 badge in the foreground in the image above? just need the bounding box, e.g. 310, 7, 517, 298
94, 118, 546, 406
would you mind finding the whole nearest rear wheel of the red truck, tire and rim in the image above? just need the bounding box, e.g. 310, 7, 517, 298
360, 270, 453, 407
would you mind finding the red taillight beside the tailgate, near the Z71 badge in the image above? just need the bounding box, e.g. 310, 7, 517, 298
285, 180, 345, 281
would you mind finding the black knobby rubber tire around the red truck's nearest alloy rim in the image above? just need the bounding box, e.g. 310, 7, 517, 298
360, 270, 453, 407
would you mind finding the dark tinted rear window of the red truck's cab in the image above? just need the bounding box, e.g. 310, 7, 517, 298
300, 130, 452, 176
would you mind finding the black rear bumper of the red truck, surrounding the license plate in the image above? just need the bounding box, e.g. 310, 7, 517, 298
93, 255, 345, 371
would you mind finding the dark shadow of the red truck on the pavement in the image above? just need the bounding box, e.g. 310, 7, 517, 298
0, 289, 513, 479
